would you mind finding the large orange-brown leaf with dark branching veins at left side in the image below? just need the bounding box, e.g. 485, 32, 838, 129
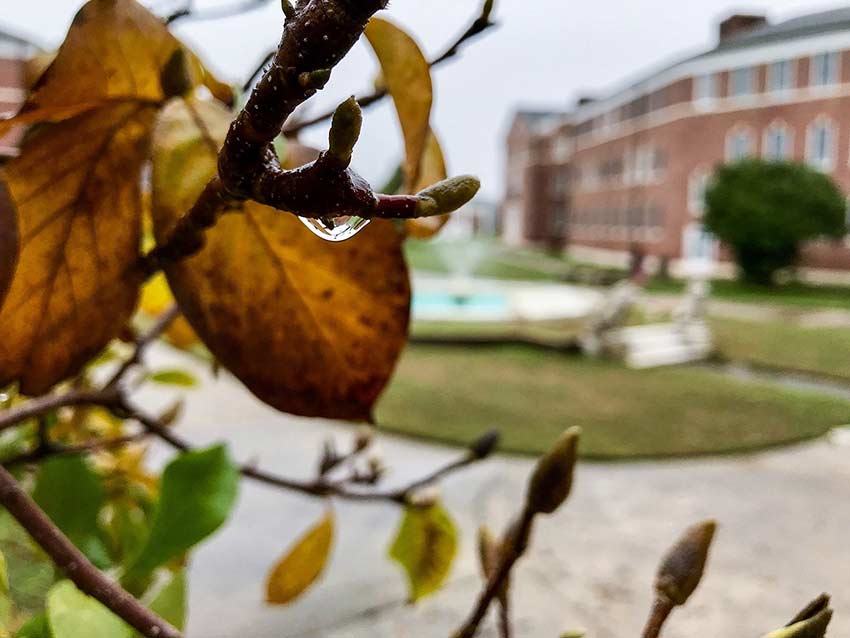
0, 104, 155, 394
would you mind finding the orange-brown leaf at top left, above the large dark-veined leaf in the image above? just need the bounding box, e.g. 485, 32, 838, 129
0, 0, 222, 135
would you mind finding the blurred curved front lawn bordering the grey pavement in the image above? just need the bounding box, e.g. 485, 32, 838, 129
377, 345, 850, 459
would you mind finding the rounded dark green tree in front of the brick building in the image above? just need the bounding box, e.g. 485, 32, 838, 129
705, 159, 847, 285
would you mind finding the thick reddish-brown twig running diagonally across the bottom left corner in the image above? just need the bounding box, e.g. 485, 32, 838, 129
0, 467, 180, 638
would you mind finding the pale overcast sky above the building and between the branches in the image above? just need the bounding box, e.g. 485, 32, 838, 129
0, 0, 842, 199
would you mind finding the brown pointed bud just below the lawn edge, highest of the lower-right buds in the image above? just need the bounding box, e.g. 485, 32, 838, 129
526, 428, 581, 514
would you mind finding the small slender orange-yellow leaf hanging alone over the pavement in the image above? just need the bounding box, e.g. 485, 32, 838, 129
266, 510, 334, 605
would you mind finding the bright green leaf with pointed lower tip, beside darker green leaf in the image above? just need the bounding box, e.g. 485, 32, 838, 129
129, 445, 239, 577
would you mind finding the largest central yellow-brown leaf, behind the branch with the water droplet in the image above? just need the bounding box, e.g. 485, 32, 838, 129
153, 101, 410, 419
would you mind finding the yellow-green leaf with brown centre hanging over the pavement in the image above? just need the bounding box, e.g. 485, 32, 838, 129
390, 505, 457, 602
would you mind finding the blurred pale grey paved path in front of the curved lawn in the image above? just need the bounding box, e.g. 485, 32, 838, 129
139, 351, 850, 638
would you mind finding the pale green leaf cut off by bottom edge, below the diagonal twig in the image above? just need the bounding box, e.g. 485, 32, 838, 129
47, 580, 134, 638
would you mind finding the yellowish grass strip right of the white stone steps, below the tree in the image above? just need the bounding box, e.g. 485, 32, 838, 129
711, 319, 850, 380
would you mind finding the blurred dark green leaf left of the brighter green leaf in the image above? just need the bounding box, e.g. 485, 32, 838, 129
33, 455, 109, 568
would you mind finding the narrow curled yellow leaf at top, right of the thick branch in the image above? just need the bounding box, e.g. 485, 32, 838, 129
365, 18, 433, 191
